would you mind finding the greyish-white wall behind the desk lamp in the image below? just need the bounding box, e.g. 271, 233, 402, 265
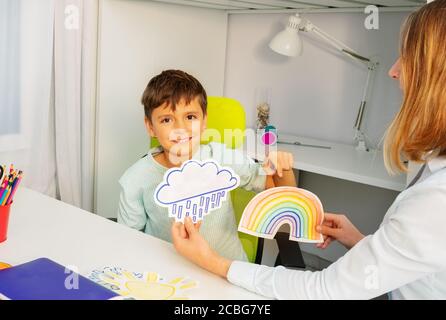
224, 12, 407, 148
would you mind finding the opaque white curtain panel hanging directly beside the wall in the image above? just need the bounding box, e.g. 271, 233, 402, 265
54, 0, 98, 211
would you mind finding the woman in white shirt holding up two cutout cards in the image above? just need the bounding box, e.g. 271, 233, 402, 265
172, 0, 446, 299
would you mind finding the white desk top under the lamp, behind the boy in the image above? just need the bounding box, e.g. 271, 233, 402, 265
246, 132, 406, 191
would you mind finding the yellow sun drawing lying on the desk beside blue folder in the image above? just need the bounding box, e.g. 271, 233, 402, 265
89, 267, 197, 300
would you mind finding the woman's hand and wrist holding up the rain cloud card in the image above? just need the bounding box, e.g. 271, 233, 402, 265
171, 217, 232, 278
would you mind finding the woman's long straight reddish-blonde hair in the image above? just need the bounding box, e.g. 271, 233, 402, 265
384, 0, 446, 173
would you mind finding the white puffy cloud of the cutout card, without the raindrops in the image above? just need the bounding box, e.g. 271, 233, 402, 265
154, 160, 240, 206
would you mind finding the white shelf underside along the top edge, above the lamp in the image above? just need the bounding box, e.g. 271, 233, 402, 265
149, 0, 426, 12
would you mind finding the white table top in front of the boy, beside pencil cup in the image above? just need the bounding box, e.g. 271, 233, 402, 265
0, 188, 263, 300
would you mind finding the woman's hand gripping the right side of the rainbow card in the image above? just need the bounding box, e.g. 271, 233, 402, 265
316, 213, 364, 249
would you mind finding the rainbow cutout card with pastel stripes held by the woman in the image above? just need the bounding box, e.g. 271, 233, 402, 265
238, 187, 324, 243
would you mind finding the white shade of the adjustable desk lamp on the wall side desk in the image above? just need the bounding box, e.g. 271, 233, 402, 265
269, 16, 302, 57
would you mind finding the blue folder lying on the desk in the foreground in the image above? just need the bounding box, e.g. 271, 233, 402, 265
0, 258, 118, 300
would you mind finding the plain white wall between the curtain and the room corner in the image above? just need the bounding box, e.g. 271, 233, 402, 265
96, 0, 227, 217
